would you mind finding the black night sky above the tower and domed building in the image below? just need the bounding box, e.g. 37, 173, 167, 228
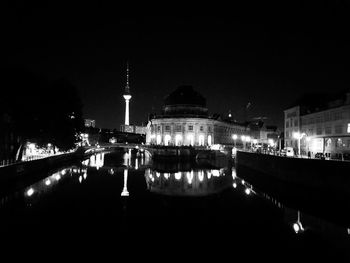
1, 1, 350, 128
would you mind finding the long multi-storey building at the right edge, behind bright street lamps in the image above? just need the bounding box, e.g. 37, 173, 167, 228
284, 92, 350, 157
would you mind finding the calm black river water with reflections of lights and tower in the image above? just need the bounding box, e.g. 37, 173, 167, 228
0, 150, 350, 262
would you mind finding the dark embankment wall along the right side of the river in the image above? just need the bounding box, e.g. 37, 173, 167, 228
235, 151, 350, 226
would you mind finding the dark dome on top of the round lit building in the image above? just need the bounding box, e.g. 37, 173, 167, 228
163, 85, 208, 116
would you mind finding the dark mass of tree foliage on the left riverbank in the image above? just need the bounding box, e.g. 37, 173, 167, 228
0, 68, 84, 161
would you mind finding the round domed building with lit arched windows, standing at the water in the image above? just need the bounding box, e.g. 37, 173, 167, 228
146, 85, 248, 146
